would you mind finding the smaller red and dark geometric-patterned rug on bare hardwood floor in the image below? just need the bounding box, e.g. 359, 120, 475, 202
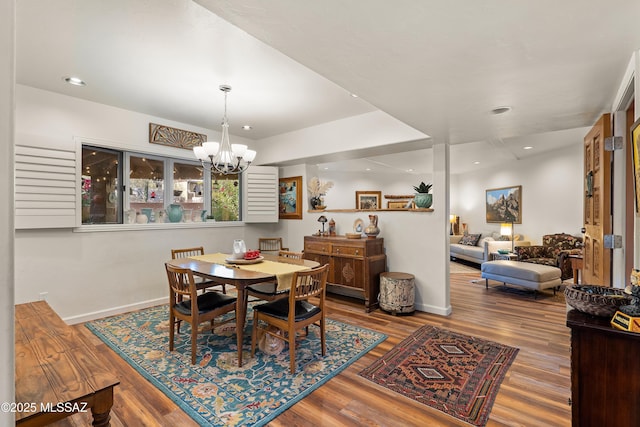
360, 325, 518, 426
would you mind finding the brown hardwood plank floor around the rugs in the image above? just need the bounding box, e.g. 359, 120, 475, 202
48, 273, 571, 427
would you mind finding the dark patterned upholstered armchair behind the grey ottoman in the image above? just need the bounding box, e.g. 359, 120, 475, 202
514, 233, 582, 280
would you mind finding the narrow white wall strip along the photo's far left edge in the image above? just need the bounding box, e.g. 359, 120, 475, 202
0, 0, 15, 426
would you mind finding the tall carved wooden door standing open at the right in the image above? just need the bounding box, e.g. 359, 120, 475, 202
583, 114, 612, 286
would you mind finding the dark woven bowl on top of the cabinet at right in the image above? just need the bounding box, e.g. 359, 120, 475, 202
564, 285, 631, 317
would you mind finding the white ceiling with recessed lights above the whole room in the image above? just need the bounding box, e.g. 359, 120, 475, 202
16, 0, 640, 172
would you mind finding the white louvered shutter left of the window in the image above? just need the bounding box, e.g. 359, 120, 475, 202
14, 135, 78, 229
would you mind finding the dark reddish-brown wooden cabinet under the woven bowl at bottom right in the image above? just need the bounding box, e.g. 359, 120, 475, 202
567, 310, 640, 427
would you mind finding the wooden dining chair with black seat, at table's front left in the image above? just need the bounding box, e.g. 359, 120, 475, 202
165, 263, 237, 365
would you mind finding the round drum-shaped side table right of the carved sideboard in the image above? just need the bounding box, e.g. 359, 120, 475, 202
378, 272, 416, 315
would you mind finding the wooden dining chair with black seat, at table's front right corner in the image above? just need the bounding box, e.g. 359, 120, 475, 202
251, 264, 329, 374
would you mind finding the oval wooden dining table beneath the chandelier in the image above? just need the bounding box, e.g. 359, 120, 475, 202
167, 254, 320, 367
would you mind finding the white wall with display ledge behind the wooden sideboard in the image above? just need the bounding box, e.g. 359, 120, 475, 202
255, 147, 451, 315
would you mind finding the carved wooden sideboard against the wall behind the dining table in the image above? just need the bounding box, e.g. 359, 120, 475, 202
304, 236, 387, 311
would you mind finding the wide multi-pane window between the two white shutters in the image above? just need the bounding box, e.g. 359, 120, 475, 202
80, 145, 241, 224
